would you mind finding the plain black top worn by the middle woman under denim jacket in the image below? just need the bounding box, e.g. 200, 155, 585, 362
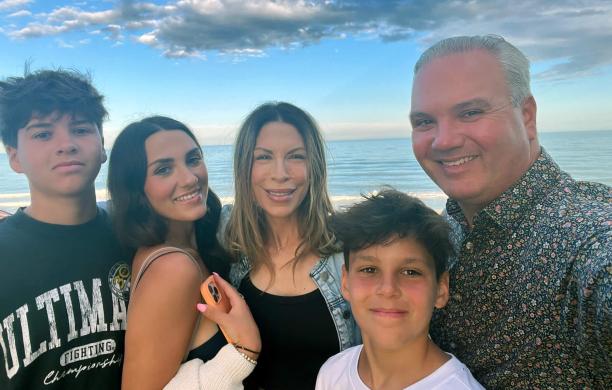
239, 277, 340, 390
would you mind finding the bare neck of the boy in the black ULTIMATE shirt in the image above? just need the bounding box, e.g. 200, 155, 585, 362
25, 187, 97, 225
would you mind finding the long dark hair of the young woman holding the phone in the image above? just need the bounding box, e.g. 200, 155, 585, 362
108, 116, 225, 268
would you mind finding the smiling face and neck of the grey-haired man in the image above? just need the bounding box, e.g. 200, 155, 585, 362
410, 50, 540, 220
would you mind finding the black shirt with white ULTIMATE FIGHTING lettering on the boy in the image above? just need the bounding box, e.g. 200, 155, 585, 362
0, 209, 131, 389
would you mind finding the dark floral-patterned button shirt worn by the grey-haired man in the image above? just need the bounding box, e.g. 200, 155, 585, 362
431, 150, 612, 389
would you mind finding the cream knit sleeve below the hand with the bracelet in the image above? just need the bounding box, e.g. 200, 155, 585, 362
164, 344, 255, 390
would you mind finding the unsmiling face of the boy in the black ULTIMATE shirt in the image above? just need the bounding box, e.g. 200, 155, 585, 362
6, 112, 106, 199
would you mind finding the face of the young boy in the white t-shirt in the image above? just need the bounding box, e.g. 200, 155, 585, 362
342, 238, 448, 350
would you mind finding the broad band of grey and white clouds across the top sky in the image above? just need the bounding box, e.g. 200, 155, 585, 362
0, 0, 612, 79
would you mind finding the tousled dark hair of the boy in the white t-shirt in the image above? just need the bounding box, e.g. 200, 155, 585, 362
331, 187, 453, 278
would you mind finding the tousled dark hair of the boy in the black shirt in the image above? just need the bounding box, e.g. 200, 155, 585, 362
0, 69, 108, 148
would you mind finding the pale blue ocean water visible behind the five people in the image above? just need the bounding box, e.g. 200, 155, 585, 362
0, 131, 612, 212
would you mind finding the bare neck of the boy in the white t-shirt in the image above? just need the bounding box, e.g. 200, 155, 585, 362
358, 337, 450, 389
